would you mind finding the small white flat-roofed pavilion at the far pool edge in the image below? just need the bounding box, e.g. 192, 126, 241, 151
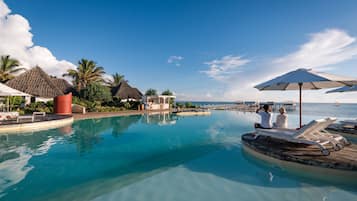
142, 95, 176, 110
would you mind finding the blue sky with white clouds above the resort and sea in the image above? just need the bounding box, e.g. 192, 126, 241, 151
0, 0, 357, 102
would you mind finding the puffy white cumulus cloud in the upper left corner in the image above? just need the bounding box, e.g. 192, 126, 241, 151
0, 0, 75, 77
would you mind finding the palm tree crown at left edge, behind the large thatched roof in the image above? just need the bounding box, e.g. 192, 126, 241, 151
0, 55, 25, 83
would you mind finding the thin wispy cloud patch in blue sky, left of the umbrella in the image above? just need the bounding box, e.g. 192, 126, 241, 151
201, 55, 250, 81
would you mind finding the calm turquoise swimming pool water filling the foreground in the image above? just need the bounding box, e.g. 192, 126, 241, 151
0, 111, 357, 201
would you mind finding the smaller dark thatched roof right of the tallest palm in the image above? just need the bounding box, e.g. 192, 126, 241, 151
112, 81, 143, 100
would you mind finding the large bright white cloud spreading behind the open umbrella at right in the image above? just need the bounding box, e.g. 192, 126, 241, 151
200, 29, 357, 102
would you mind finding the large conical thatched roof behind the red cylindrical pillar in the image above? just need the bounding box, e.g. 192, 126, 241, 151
6, 67, 64, 98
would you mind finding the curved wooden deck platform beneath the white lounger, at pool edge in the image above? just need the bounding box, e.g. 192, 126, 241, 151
242, 133, 357, 172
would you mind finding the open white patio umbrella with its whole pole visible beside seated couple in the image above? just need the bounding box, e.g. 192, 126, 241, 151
255, 68, 357, 128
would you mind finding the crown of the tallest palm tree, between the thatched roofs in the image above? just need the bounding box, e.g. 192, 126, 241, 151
63, 59, 105, 91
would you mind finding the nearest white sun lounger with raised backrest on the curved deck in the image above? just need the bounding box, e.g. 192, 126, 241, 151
256, 118, 349, 155
